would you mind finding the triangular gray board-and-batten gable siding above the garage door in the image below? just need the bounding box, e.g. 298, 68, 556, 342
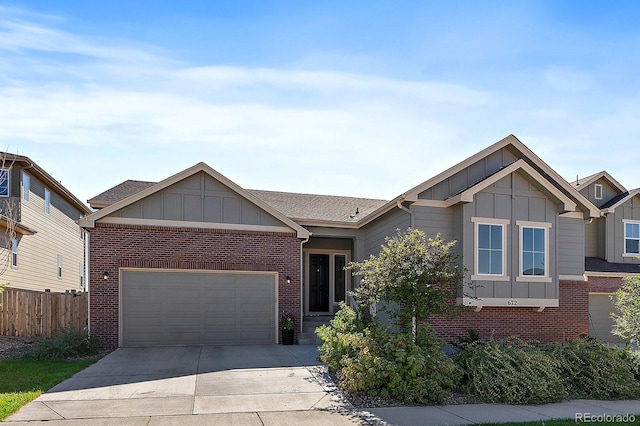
112, 172, 286, 226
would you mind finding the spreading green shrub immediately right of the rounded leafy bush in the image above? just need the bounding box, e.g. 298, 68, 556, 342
455, 338, 566, 404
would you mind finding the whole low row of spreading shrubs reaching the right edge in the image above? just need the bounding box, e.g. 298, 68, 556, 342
455, 338, 640, 404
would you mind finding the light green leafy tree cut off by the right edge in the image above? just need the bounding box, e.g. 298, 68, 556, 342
611, 277, 640, 344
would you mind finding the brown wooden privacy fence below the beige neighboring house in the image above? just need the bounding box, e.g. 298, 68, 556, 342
0, 288, 89, 337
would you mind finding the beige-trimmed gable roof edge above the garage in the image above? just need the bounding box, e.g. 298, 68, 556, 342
80, 162, 309, 238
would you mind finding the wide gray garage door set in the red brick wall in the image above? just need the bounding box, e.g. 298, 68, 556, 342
120, 270, 276, 347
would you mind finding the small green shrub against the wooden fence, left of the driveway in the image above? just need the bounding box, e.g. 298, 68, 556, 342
31, 328, 100, 360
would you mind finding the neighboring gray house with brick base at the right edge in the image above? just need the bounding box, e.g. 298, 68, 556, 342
572, 171, 640, 342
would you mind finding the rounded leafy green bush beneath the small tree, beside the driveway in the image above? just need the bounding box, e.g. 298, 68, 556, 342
316, 305, 461, 404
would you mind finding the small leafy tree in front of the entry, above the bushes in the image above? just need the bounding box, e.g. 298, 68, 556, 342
348, 229, 466, 337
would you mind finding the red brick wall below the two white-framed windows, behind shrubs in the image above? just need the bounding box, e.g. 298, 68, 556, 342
430, 281, 589, 343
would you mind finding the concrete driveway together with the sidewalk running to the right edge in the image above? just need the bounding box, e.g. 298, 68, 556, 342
6, 345, 640, 426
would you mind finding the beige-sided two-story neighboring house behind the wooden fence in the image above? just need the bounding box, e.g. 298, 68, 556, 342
0, 153, 91, 292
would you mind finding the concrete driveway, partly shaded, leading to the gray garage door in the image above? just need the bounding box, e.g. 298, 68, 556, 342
6, 345, 362, 426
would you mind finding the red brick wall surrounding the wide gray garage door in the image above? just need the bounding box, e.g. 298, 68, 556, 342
89, 223, 302, 347
